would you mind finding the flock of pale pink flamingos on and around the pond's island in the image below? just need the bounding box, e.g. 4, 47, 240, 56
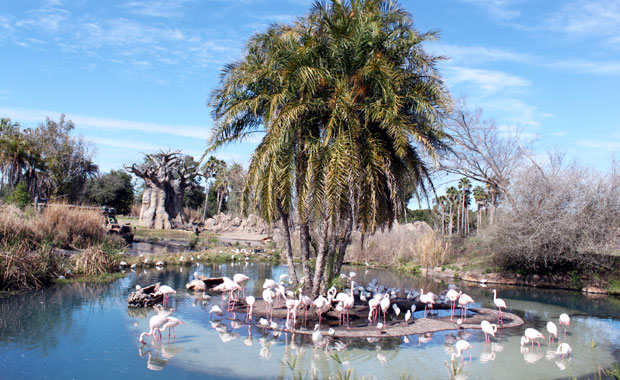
139, 272, 572, 372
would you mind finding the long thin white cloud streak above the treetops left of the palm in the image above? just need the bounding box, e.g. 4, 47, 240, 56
0, 108, 211, 141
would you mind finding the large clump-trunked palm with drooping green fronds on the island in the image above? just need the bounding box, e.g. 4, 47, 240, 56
211, 0, 448, 294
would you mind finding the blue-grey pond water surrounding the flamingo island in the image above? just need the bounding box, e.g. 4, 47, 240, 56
0, 263, 620, 379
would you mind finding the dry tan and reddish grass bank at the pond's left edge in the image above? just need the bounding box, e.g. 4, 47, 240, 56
0, 204, 124, 291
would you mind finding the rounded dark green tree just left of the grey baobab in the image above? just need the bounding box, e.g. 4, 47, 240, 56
85, 170, 134, 214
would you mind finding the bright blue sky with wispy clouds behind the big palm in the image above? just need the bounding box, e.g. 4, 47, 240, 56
0, 0, 620, 171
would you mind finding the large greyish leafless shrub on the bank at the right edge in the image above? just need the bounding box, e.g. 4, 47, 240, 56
488, 156, 620, 273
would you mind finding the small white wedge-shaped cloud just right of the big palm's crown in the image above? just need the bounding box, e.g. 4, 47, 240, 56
446, 66, 531, 94
